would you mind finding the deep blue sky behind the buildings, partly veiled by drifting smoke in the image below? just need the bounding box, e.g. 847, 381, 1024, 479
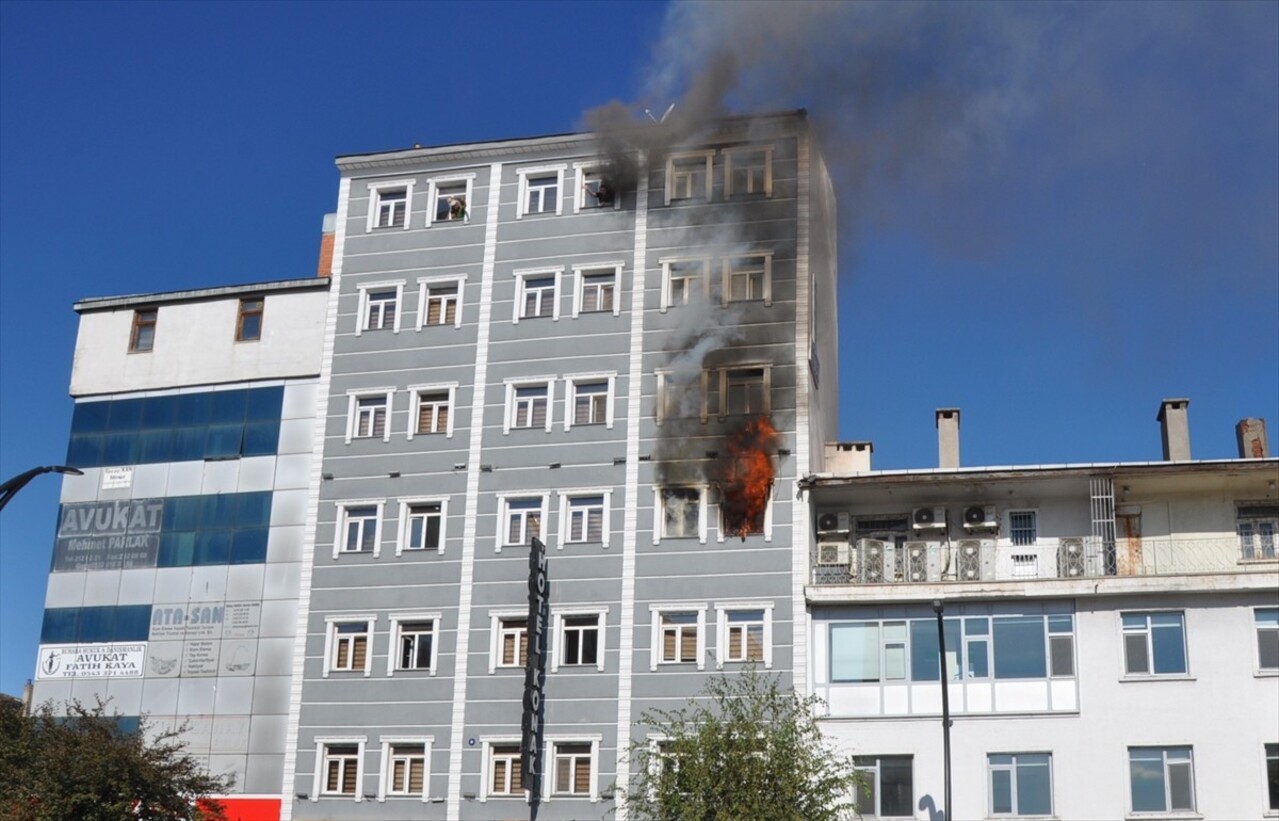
0, 0, 1279, 693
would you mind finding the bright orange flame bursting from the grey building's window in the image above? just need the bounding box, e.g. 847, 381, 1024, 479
719, 416, 778, 540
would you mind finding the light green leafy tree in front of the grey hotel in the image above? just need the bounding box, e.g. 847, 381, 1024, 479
619, 669, 859, 821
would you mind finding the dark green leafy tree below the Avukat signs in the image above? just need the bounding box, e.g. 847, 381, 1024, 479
0, 698, 230, 821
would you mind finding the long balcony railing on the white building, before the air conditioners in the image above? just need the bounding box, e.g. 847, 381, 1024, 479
811, 536, 1279, 584
